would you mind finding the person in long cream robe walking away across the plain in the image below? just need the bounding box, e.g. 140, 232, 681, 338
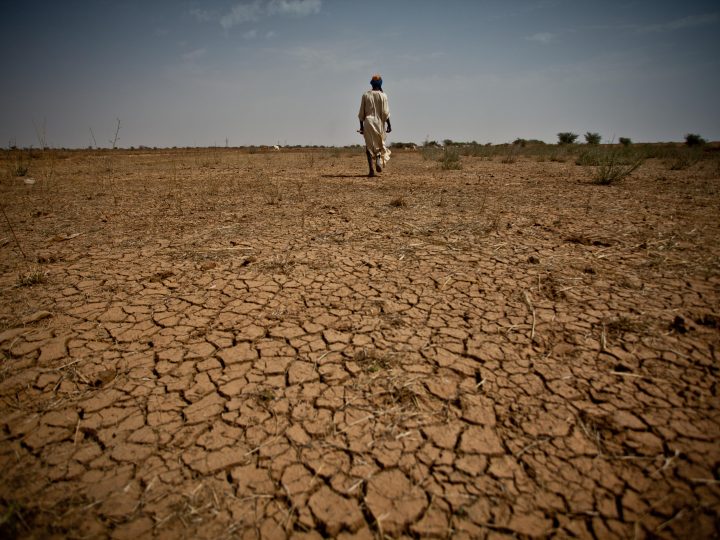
358, 75, 392, 176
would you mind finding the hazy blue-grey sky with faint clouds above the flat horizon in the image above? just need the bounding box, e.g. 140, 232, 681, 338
0, 0, 720, 147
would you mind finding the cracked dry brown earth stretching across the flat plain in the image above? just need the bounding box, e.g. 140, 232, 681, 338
0, 150, 720, 539
